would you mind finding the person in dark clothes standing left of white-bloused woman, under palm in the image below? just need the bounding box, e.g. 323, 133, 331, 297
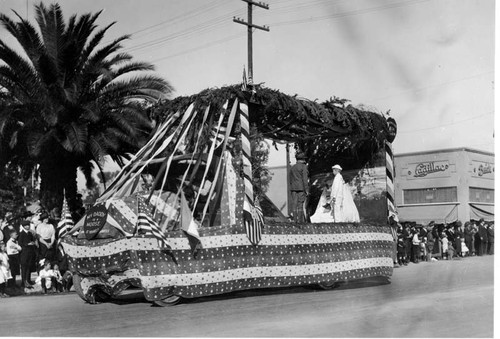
19, 220, 37, 288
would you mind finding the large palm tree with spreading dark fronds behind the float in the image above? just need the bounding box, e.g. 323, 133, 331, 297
0, 3, 173, 215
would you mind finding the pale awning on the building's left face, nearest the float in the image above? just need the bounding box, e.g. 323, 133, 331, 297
398, 204, 458, 225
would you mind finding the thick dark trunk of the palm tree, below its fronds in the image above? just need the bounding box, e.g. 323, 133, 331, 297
40, 159, 78, 212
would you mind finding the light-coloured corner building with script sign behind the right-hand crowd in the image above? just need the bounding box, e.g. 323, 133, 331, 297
394, 148, 495, 224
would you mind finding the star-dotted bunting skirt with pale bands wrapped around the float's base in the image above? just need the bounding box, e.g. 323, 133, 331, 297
65, 225, 393, 300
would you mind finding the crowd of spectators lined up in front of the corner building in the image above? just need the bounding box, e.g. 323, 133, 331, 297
395, 219, 495, 266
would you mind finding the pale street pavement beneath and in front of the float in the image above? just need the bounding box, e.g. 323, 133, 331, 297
0, 256, 494, 338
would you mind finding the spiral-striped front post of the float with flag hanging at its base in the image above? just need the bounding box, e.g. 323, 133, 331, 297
240, 103, 263, 245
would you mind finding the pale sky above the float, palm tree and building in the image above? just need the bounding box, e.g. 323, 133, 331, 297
0, 0, 495, 166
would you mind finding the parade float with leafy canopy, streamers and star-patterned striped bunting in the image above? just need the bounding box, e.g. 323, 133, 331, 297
61, 86, 395, 306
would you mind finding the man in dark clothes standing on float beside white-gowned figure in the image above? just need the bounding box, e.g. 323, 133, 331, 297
290, 152, 309, 222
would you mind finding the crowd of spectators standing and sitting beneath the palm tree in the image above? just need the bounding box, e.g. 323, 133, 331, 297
0, 209, 73, 298
